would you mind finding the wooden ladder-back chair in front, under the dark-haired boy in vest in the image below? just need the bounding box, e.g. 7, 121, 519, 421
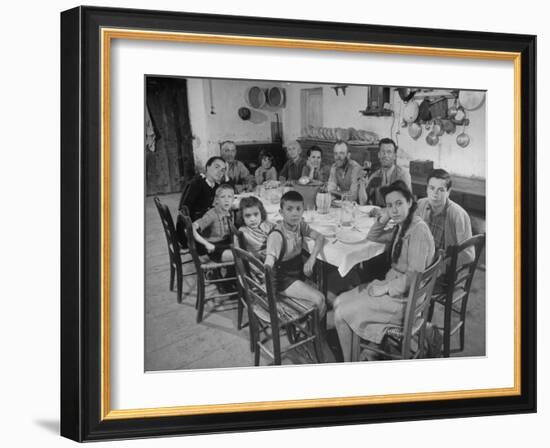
233, 247, 323, 366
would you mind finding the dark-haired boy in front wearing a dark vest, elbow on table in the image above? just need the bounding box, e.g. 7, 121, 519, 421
265, 190, 326, 318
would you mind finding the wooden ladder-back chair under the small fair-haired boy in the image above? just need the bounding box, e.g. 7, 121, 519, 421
178, 207, 243, 322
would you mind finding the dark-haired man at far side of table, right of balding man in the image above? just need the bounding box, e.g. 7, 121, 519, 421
359, 138, 412, 207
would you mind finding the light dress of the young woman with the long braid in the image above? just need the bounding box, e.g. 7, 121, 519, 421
334, 216, 435, 344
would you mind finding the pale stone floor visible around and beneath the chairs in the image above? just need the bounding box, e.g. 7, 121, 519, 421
145, 194, 485, 371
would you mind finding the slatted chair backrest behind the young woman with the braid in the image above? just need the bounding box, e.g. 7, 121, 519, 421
401, 255, 443, 359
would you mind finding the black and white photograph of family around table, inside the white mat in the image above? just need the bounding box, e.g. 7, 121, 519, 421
144, 75, 488, 371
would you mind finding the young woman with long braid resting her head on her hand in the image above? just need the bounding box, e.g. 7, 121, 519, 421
334, 180, 435, 361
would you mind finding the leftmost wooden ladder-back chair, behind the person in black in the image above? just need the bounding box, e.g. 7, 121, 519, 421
154, 197, 195, 303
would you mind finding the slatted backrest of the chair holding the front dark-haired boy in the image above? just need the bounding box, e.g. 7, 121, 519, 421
233, 245, 280, 353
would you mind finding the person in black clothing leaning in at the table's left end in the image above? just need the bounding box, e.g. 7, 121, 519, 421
179, 156, 226, 221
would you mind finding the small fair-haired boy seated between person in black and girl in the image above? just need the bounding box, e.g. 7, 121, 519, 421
193, 184, 235, 263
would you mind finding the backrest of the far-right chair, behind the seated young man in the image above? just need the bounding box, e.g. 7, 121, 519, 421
445, 233, 485, 299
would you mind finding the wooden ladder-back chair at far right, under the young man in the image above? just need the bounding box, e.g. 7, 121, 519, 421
428, 233, 485, 357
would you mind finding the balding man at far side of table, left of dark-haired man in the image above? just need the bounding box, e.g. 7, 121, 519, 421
328, 141, 363, 201
